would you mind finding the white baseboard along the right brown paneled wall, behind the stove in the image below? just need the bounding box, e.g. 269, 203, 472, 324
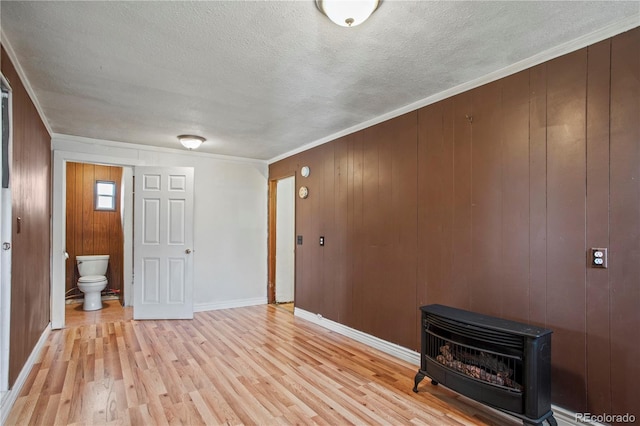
293, 308, 605, 426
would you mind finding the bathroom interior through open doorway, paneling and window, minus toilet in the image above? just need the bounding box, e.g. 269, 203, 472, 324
65, 162, 126, 311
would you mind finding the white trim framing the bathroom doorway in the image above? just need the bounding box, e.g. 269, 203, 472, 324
50, 150, 146, 330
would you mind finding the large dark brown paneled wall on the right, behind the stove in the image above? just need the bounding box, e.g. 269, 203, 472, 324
269, 28, 640, 415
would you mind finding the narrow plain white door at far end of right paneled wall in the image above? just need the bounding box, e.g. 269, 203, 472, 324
276, 176, 296, 303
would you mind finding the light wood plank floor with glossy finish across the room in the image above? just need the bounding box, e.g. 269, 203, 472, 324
7, 305, 521, 425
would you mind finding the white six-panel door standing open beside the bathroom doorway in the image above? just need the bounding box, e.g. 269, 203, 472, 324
133, 167, 194, 319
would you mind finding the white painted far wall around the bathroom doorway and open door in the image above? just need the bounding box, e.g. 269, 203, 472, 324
52, 134, 268, 328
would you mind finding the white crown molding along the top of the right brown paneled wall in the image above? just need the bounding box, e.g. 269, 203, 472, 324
268, 16, 640, 164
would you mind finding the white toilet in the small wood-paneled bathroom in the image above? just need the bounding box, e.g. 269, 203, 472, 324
76, 254, 109, 311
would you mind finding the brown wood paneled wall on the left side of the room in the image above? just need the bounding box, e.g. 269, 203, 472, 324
0, 48, 51, 386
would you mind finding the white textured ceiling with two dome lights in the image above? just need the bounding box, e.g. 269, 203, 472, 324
0, 0, 640, 159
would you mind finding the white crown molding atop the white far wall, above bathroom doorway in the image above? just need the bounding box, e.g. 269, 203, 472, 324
51, 133, 267, 166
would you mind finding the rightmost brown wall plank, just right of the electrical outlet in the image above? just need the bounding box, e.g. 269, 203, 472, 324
599, 29, 640, 418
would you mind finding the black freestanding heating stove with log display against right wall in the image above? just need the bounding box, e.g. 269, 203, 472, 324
413, 305, 557, 426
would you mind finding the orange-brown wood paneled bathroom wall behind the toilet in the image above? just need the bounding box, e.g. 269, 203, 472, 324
65, 162, 124, 299
